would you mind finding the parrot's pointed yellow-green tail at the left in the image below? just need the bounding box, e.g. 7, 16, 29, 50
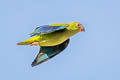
17, 36, 39, 45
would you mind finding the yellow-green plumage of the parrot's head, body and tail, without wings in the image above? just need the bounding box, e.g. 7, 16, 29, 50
18, 22, 82, 46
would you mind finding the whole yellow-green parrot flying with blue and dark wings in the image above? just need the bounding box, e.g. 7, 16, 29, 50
17, 22, 85, 67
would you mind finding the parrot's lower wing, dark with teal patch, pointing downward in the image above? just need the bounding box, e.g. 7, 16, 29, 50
32, 39, 69, 67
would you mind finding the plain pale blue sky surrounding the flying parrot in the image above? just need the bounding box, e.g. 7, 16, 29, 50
0, 0, 120, 80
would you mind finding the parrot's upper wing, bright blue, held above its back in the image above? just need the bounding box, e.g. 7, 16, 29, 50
30, 25, 67, 37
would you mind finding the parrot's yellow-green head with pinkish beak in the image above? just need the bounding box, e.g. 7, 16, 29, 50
68, 22, 85, 32
